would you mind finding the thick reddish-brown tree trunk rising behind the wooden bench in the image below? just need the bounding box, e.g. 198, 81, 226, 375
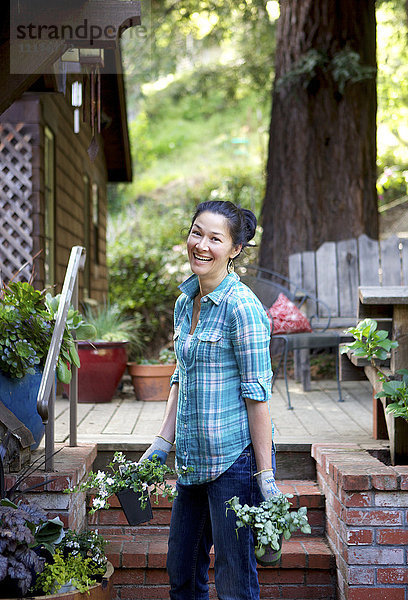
260, 0, 378, 273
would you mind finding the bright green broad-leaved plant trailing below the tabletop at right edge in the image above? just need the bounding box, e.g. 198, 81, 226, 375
340, 319, 408, 421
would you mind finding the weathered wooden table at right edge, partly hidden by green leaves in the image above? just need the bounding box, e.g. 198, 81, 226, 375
357, 286, 408, 460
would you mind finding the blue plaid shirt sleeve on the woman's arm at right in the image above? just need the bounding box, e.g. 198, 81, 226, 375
231, 298, 272, 402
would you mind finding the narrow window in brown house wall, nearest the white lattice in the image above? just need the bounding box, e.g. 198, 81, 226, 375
44, 126, 55, 286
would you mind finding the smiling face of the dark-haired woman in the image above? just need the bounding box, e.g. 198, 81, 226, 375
187, 211, 241, 283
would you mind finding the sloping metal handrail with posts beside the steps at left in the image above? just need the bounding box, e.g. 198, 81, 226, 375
37, 246, 86, 471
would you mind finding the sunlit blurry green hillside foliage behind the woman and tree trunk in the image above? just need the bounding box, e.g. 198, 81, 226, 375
108, 0, 408, 355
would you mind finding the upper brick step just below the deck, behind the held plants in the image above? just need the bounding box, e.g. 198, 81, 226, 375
88, 480, 325, 541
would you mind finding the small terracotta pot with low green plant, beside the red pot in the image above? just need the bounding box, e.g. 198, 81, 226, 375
127, 348, 176, 402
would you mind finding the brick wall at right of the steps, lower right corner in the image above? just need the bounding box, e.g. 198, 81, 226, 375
312, 444, 408, 600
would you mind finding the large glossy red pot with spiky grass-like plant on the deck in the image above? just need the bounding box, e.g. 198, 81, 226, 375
65, 304, 141, 402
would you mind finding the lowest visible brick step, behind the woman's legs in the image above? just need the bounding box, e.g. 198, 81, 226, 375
107, 535, 336, 600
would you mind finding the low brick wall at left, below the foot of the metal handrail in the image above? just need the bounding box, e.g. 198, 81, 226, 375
5, 444, 96, 531
